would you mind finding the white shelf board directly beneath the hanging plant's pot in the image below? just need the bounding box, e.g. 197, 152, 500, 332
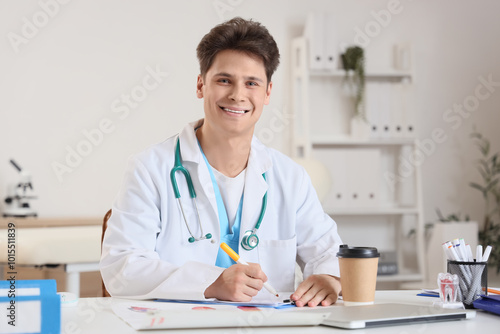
311, 136, 415, 147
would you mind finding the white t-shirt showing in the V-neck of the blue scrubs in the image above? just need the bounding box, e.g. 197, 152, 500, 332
212, 167, 246, 228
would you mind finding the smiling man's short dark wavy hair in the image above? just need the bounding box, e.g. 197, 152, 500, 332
196, 17, 280, 83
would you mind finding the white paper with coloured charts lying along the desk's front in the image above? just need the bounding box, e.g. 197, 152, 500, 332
111, 300, 328, 330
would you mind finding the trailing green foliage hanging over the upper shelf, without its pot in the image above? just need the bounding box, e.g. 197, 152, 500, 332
341, 46, 366, 121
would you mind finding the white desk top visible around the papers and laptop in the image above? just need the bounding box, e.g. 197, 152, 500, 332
61, 290, 500, 334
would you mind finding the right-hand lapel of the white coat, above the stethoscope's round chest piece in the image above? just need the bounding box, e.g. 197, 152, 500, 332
240, 137, 272, 262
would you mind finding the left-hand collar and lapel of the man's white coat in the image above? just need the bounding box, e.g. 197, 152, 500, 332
179, 119, 220, 241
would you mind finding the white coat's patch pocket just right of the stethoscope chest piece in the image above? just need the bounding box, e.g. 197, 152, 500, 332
257, 236, 297, 292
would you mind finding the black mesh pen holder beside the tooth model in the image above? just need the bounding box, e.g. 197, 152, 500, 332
448, 260, 488, 308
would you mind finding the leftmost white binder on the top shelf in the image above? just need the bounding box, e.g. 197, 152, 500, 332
304, 12, 326, 70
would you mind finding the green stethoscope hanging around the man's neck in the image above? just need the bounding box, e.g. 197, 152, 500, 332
170, 138, 267, 250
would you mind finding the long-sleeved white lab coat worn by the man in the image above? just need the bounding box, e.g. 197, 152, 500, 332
100, 120, 342, 299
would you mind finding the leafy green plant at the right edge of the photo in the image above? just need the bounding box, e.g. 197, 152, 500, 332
470, 132, 500, 274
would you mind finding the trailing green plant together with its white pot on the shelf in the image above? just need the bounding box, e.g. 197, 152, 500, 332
341, 46, 370, 139
